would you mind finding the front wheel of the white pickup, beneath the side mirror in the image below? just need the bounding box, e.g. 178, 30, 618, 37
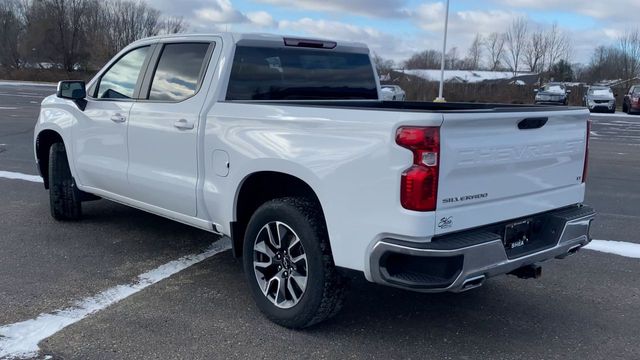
49, 143, 82, 221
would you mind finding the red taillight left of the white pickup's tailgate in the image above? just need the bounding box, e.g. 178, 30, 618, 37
396, 126, 440, 211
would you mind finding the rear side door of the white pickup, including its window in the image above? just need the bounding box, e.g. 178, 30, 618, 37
127, 41, 215, 216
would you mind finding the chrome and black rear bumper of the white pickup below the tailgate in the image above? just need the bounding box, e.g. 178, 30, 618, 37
370, 206, 595, 292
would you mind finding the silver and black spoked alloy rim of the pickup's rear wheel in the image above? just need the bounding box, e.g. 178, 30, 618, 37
253, 221, 308, 309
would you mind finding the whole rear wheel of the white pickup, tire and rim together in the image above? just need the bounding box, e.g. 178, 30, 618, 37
243, 197, 344, 329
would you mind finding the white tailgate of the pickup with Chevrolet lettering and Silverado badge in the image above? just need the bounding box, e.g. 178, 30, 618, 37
435, 109, 589, 234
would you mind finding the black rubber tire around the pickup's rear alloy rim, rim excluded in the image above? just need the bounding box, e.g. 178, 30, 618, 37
243, 197, 345, 329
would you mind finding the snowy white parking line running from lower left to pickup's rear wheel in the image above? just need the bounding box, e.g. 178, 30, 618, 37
0, 238, 231, 359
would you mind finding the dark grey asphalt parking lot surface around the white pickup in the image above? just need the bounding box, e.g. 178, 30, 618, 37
0, 84, 640, 359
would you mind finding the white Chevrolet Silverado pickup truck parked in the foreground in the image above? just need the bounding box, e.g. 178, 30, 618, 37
34, 33, 594, 328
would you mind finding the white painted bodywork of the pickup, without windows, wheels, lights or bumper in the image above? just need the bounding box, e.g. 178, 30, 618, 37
35, 34, 588, 279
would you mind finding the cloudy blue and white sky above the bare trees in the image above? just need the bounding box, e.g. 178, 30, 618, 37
149, 0, 640, 62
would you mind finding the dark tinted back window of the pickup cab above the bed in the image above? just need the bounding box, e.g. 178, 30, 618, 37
226, 45, 378, 100
